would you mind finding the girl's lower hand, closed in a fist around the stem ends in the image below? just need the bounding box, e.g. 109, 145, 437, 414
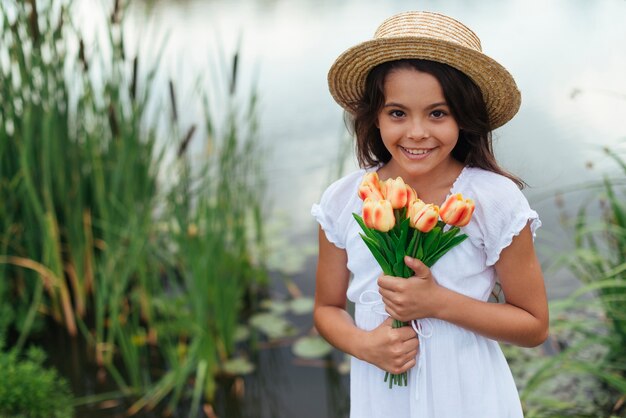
359, 318, 419, 374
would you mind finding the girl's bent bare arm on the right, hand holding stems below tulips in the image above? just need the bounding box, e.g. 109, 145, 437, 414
378, 225, 548, 347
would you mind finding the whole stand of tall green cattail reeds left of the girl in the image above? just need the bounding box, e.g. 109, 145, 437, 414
0, 0, 264, 412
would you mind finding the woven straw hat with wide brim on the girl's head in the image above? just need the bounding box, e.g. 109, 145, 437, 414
328, 12, 521, 129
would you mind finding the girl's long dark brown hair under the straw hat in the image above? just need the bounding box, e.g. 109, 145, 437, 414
352, 59, 525, 188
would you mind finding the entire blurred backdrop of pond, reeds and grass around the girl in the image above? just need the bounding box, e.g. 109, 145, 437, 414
0, 0, 626, 417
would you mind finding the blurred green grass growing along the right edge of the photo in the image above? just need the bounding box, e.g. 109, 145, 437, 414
523, 149, 626, 416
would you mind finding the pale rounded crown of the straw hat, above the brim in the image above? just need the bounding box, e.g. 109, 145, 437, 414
374, 12, 482, 52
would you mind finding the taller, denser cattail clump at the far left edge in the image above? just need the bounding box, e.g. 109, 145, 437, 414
0, 0, 163, 396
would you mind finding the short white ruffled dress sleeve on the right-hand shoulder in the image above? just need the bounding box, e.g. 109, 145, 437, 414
470, 177, 541, 265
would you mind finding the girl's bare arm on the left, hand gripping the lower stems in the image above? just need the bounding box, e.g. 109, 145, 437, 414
313, 228, 418, 374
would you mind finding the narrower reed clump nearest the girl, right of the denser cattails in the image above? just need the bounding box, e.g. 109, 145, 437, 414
131, 55, 266, 411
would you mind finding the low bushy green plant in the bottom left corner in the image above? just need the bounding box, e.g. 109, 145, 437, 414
0, 347, 73, 418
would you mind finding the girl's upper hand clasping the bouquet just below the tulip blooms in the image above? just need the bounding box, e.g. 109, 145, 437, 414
378, 257, 444, 322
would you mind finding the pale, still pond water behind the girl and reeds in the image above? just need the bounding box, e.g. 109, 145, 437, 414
61, 0, 626, 417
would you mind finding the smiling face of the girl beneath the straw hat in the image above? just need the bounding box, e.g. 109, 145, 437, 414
377, 68, 459, 181
